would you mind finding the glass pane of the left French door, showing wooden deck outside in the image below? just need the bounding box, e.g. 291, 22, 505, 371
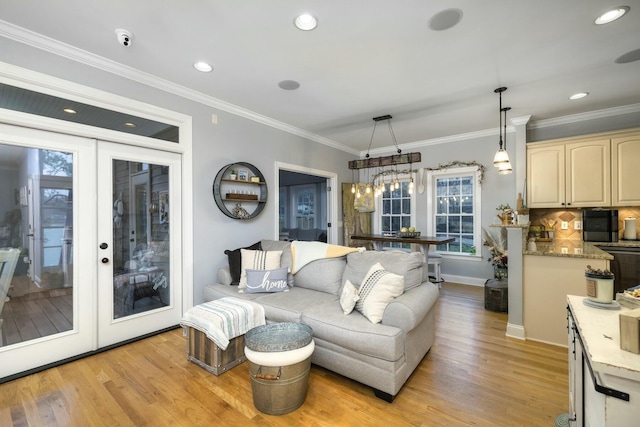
0, 144, 74, 346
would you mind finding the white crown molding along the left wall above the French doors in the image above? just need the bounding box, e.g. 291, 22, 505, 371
0, 20, 359, 155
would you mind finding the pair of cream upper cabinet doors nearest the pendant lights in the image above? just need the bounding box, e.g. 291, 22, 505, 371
527, 138, 611, 208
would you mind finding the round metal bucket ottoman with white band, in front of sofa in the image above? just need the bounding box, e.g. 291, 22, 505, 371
244, 323, 315, 415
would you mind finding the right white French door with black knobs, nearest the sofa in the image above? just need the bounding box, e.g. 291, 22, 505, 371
97, 141, 182, 347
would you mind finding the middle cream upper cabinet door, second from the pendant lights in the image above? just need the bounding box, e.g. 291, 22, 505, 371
565, 139, 608, 207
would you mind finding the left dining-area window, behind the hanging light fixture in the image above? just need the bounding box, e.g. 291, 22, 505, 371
376, 180, 415, 249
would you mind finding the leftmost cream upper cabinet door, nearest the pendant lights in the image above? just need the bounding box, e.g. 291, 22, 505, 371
527, 144, 565, 208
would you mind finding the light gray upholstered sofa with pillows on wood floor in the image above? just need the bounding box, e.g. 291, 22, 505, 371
204, 240, 439, 402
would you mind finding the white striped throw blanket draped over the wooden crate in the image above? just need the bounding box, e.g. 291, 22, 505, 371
180, 297, 265, 350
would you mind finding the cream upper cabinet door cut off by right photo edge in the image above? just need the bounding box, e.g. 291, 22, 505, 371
611, 133, 640, 206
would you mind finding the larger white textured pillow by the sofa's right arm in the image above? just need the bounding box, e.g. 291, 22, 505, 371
355, 262, 404, 323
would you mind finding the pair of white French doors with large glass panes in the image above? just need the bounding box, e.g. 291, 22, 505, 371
0, 124, 183, 378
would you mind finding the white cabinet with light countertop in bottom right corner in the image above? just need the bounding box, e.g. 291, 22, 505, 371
567, 295, 640, 427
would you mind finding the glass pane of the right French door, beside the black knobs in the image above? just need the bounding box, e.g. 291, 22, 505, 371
112, 160, 171, 318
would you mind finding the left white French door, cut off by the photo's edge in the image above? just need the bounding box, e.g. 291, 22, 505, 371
0, 124, 98, 377
